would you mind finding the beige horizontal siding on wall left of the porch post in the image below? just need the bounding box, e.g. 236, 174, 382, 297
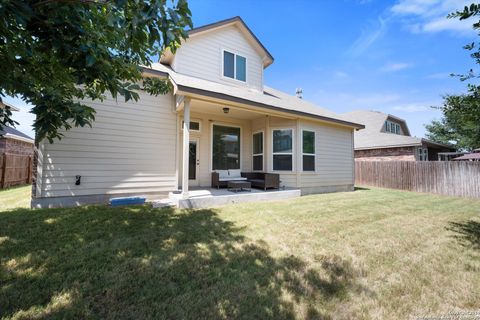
37, 90, 177, 197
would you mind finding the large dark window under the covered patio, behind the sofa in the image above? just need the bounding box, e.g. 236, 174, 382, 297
212, 125, 240, 170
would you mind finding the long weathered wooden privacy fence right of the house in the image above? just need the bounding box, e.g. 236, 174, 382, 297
355, 161, 480, 197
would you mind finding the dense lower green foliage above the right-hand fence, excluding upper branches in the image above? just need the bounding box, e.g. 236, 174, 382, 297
426, 85, 480, 151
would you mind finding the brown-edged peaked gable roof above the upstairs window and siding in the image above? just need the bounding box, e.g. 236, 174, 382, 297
160, 16, 274, 68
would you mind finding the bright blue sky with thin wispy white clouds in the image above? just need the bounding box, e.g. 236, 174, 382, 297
5, 0, 478, 137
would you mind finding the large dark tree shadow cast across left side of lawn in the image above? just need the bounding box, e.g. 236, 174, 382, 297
0, 207, 363, 319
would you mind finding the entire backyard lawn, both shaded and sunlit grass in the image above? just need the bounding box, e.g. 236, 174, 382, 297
0, 188, 480, 319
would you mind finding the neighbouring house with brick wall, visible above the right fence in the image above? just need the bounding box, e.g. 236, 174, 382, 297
344, 110, 455, 161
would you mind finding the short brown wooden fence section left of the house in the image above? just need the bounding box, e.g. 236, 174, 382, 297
0, 153, 33, 189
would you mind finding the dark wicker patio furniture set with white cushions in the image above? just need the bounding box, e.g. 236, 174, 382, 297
212, 170, 280, 192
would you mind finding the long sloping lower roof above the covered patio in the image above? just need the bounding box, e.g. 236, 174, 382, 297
144, 63, 364, 129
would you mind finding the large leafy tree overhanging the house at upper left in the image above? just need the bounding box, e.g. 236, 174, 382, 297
0, 0, 192, 142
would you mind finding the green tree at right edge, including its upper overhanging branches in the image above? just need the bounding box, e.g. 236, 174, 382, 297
425, 4, 480, 150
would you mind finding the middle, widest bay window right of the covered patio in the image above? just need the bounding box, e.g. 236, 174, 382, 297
272, 129, 293, 171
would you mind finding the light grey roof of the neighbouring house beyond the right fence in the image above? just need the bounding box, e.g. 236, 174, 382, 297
343, 110, 455, 150
